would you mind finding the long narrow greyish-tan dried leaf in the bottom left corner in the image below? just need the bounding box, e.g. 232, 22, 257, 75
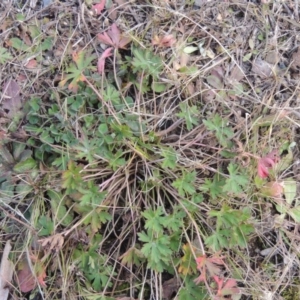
0, 240, 14, 300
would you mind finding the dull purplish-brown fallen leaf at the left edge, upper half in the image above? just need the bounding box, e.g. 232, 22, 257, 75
2, 79, 23, 118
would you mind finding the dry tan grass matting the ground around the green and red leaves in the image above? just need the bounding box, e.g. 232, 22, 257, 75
0, 1, 300, 300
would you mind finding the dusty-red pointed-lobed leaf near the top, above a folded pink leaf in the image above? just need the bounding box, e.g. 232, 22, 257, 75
97, 23, 131, 49
